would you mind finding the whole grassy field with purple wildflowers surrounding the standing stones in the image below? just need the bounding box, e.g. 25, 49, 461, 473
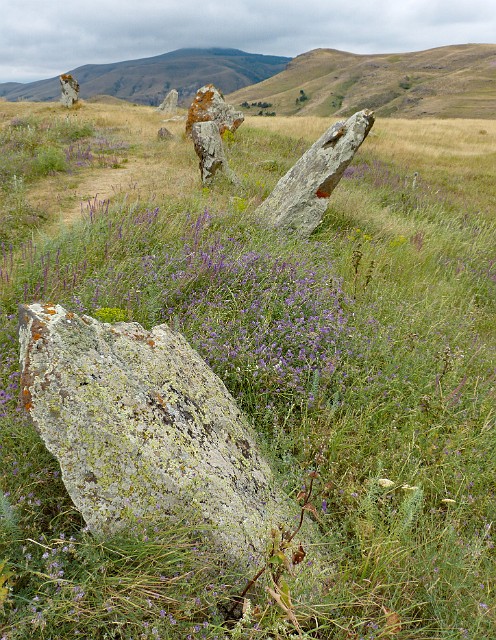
0, 102, 496, 640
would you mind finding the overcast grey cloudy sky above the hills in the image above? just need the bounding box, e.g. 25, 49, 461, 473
0, 0, 496, 82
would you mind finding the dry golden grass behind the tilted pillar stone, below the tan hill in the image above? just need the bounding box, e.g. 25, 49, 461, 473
247, 116, 496, 215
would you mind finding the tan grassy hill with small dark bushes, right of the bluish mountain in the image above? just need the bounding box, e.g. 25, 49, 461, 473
228, 44, 496, 118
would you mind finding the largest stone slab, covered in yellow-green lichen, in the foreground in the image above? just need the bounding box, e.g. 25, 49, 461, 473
19, 303, 316, 564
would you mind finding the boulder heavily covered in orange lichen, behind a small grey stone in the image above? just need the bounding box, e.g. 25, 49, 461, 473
186, 84, 245, 136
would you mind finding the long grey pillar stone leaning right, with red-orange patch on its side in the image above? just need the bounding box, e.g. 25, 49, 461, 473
256, 110, 374, 236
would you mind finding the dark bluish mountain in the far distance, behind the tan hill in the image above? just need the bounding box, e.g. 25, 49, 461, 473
0, 48, 291, 105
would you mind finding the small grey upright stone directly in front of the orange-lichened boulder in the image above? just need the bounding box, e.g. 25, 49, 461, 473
191, 121, 237, 184
